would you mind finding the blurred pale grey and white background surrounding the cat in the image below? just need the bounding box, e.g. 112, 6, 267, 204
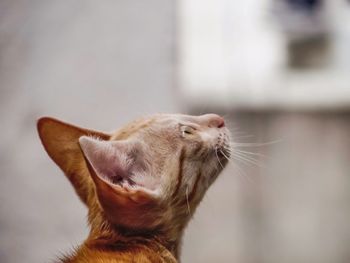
0, 0, 350, 263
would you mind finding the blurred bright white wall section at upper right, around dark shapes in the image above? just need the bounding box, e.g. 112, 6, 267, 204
178, 0, 350, 110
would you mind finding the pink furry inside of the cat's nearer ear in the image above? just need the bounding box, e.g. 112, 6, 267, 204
79, 136, 158, 195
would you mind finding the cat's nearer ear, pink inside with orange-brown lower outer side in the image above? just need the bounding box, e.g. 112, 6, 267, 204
79, 136, 159, 229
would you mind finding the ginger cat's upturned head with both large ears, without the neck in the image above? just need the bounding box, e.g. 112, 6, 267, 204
38, 114, 230, 237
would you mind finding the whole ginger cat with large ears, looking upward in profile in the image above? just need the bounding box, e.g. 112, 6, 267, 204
37, 114, 230, 263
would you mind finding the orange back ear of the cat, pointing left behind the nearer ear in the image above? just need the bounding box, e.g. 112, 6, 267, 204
37, 117, 110, 205
